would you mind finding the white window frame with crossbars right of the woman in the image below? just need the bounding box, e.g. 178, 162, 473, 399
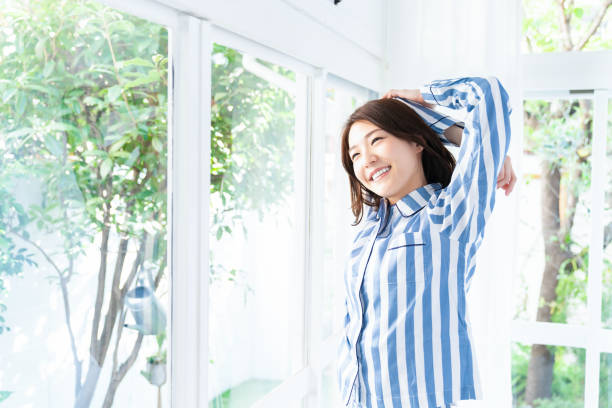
511, 51, 612, 408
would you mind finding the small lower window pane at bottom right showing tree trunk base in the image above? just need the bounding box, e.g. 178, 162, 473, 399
511, 342, 586, 408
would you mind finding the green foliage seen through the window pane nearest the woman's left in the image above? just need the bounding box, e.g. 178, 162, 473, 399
210, 44, 295, 288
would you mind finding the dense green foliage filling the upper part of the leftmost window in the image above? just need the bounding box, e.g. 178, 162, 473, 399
0, 0, 168, 334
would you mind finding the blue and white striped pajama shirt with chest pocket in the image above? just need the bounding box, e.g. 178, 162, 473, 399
338, 77, 511, 408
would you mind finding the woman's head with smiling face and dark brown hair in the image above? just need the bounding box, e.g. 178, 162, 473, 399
342, 99, 455, 225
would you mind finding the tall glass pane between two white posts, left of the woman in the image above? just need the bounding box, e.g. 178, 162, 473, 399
208, 44, 306, 407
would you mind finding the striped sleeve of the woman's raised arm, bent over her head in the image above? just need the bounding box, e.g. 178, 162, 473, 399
420, 77, 511, 242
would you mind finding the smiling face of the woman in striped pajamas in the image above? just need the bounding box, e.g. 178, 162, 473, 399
348, 121, 427, 204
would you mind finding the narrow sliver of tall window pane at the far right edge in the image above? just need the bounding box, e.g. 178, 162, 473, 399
601, 99, 612, 329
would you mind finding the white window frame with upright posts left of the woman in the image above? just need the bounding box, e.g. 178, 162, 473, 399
97, 0, 378, 408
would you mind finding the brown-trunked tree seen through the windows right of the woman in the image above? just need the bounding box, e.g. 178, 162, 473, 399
516, 0, 612, 406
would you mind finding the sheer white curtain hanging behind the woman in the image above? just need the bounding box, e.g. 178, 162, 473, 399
381, 0, 523, 407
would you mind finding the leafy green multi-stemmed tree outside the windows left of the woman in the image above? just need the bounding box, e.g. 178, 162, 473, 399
0, 0, 295, 407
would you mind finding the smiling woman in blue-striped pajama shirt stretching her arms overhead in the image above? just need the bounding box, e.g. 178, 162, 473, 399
338, 77, 516, 408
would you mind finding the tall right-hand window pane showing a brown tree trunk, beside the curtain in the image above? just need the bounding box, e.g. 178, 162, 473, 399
514, 99, 592, 324
